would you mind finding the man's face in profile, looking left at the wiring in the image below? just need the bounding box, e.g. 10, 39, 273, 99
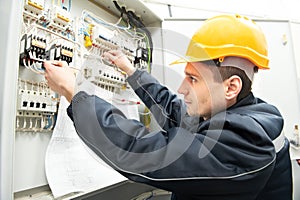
178, 62, 226, 119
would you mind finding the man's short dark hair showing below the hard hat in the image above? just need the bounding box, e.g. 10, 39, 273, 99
213, 66, 257, 101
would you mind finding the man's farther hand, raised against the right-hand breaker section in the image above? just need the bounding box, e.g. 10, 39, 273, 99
103, 50, 135, 76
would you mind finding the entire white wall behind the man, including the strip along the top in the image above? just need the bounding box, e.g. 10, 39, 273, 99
143, 0, 300, 137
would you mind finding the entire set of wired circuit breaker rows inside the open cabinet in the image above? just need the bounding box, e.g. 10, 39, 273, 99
16, 0, 150, 132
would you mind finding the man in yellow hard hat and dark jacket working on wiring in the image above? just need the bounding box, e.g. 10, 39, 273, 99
44, 15, 292, 200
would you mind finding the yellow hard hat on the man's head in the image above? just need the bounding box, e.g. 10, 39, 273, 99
171, 15, 269, 69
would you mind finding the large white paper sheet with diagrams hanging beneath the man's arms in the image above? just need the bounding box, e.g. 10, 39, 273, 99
45, 82, 139, 198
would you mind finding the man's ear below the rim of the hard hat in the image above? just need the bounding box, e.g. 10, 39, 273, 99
224, 75, 243, 101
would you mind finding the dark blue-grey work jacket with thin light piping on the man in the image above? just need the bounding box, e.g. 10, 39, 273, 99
68, 70, 292, 200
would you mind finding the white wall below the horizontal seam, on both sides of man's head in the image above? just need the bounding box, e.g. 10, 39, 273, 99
162, 19, 300, 138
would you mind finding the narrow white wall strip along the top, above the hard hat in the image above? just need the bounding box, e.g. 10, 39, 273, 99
143, 0, 300, 21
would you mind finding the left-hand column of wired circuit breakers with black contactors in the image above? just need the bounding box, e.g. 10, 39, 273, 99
16, 0, 76, 132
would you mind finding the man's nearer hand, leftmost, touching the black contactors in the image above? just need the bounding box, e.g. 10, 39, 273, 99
44, 61, 76, 102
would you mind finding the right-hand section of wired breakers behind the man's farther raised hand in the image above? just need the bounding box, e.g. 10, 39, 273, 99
81, 11, 150, 93
